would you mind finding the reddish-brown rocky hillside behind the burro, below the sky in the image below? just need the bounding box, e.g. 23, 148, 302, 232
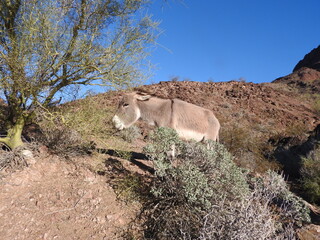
83, 45, 320, 172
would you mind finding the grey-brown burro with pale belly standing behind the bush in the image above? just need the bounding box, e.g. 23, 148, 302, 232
112, 92, 220, 142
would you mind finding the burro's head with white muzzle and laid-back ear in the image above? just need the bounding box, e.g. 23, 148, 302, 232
112, 92, 151, 130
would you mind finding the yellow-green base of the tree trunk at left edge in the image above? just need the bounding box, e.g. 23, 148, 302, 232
0, 116, 25, 150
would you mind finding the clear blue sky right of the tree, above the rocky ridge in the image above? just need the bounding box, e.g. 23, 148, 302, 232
148, 0, 320, 83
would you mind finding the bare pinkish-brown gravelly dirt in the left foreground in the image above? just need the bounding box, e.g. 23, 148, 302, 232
0, 151, 139, 240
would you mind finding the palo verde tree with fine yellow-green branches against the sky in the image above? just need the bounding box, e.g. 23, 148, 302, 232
0, 0, 157, 149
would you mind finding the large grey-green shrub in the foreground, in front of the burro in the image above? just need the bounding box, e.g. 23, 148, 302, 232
144, 128, 309, 240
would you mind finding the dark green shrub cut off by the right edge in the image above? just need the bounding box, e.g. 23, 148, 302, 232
301, 148, 320, 205
